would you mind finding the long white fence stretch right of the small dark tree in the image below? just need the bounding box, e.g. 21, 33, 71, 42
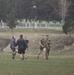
16, 23, 62, 30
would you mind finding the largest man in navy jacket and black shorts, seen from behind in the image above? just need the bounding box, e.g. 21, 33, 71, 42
16, 35, 27, 60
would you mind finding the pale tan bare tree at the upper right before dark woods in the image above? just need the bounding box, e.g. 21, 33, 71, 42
58, 0, 71, 21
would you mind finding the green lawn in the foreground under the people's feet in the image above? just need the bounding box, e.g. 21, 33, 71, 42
0, 54, 74, 75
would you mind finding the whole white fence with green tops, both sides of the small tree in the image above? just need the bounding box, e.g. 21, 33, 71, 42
0, 21, 63, 30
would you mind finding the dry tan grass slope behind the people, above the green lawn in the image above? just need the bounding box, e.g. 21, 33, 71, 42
0, 29, 74, 56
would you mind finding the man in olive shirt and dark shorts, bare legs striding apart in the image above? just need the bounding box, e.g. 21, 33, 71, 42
37, 35, 46, 59
